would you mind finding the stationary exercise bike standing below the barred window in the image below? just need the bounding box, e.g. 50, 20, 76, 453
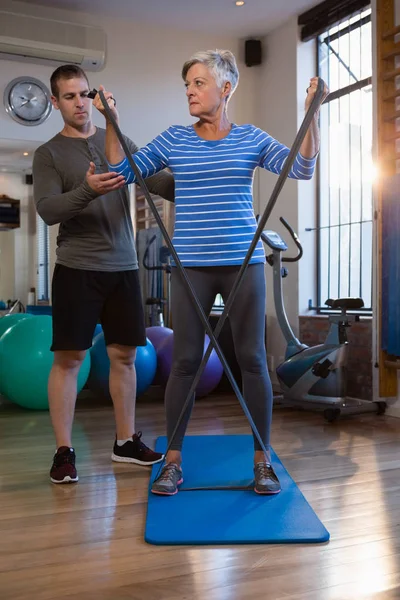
261, 217, 386, 422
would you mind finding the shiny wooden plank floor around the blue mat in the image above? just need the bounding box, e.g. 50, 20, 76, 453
0, 396, 400, 600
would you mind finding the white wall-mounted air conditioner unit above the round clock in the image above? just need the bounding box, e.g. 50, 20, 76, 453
0, 11, 106, 71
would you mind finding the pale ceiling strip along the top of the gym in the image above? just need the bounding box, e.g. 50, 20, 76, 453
25, 0, 321, 37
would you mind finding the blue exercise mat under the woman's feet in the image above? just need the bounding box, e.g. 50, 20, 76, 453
145, 435, 329, 545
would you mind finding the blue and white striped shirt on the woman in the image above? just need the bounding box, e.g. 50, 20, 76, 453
110, 124, 316, 267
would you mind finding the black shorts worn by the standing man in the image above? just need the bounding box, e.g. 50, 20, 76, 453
51, 264, 146, 351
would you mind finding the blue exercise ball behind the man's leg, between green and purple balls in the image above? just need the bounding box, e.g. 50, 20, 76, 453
88, 333, 157, 398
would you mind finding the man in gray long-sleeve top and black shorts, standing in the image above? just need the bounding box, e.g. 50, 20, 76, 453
33, 65, 174, 483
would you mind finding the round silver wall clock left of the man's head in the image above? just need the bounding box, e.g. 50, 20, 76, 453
4, 77, 52, 125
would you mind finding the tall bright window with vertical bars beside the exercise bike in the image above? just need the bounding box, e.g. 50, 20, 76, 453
317, 8, 375, 311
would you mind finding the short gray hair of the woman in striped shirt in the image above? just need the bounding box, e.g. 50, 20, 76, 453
182, 50, 239, 96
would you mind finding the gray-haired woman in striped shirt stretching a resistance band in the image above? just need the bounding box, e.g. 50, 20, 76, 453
94, 50, 328, 495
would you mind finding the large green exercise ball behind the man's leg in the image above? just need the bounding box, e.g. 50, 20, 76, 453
0, 315, 90, 410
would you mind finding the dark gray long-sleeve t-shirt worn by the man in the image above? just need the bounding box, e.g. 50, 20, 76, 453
33, 128, 174, 271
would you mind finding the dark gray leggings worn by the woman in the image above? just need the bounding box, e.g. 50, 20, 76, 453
165, 263, 273, 450
